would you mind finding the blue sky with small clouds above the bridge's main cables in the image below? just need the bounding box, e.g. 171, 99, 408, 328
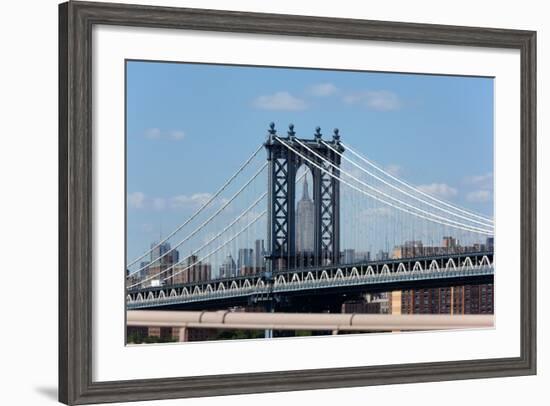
127, 61, 493, 264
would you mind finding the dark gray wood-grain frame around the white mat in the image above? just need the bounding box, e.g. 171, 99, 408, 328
59, 2, 536, 404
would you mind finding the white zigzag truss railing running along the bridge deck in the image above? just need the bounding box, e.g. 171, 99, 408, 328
126, 255, 494, 309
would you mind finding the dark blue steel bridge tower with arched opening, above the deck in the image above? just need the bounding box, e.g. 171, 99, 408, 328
265, 123, 344, 273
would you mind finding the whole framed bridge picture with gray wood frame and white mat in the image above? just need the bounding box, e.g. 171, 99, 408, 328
59, 2, 536, 404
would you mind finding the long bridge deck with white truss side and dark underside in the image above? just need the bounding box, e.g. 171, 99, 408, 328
126, 251, 494, 310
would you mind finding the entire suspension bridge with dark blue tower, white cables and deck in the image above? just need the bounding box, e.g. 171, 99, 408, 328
126, 123, 494, 312
